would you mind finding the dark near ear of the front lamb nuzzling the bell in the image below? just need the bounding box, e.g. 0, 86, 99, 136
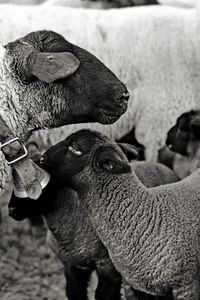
95, 146, 131, 174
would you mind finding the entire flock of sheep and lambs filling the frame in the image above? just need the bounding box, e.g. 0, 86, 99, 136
0, 0, 200, 300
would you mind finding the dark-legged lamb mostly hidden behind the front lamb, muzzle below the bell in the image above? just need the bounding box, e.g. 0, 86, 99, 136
9, 143, 178, 300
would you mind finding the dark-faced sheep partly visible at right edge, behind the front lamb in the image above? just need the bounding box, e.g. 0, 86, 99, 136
166, 110, 200, 178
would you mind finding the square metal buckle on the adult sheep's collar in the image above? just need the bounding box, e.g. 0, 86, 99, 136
1, 137, 28, 165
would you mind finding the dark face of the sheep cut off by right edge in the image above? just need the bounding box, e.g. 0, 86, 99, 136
166, 111, 200, 156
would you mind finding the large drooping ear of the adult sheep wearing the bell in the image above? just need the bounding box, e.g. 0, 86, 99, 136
29, 52, 80, 83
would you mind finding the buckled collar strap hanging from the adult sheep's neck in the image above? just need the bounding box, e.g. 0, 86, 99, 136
0, 116, 42, 199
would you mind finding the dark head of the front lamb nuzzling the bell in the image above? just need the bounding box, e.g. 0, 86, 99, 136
41, 129, 138, 190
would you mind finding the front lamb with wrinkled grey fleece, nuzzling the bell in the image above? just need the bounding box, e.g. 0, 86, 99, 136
29, 130, 200, 300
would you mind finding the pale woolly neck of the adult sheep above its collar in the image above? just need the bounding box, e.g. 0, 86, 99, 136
0, 46, 54, 141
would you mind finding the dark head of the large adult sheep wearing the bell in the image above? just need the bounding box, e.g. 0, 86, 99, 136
5, 31, 129, 127
